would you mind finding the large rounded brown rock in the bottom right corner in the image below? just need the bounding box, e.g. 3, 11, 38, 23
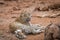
44, 24, 60, 40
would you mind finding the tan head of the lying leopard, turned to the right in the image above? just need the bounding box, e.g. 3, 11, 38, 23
20, 11, 31, 23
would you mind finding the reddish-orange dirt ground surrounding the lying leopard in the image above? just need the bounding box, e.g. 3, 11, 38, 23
0, 0, 60, 40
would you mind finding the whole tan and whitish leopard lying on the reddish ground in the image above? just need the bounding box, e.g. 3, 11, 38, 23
9, 11, 45, 39
